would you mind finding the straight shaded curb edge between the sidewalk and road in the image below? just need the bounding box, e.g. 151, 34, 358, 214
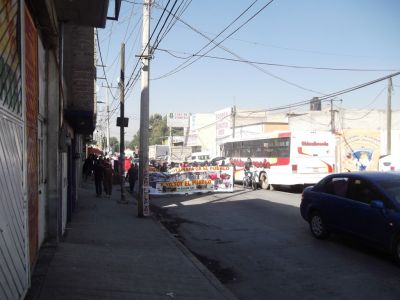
151, 214, 239, 300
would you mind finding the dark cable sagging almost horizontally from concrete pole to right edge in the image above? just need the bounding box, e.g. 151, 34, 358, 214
157, 48, 399, 72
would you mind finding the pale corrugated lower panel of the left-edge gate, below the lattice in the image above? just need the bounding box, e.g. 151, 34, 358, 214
0, 111, 27, 299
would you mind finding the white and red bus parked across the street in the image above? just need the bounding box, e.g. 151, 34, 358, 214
221, 131, 335, 189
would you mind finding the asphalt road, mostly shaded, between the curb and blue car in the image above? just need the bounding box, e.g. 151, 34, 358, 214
152, 189, 400, 300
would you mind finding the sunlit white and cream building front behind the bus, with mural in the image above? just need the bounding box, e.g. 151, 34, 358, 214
187, 105, 400, 172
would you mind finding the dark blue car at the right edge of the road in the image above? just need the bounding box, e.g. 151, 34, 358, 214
300, 172, 400, 262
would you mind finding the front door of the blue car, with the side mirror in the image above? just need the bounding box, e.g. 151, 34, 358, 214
348, 178, 394, 245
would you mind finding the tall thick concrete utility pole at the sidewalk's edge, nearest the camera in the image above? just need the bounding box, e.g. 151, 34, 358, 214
137, 0, 151, 217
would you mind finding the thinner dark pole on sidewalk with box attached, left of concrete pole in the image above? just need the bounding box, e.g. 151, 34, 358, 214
119, 43, 126, 203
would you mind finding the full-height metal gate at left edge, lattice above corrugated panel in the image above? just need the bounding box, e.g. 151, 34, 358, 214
0, 0, 29, 299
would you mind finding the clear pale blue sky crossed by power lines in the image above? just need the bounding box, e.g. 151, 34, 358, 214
97, 0, 400, 141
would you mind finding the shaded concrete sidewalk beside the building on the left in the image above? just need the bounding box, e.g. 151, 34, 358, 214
25, 182, 236, 300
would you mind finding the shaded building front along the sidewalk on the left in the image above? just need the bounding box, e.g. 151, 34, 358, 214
0, 0, 120, 299
